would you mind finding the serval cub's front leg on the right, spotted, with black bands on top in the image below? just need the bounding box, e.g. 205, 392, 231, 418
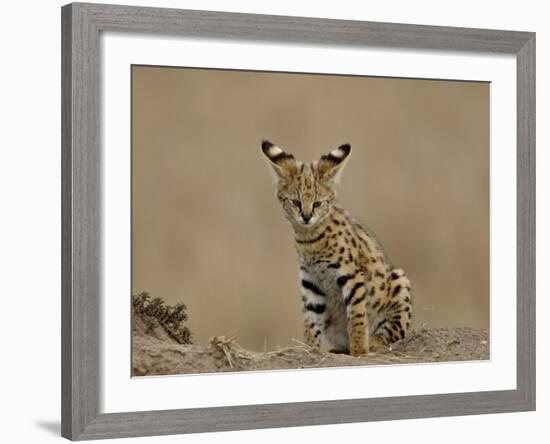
337, 271, 369, 356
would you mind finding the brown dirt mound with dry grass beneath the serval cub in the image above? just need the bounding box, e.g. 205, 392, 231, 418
132, 314, 489, 376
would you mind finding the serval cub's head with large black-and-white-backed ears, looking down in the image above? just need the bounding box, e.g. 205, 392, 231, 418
262, 141, 351, 228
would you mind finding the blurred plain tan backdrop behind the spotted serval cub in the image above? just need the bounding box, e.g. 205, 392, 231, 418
132, 67, 489, 350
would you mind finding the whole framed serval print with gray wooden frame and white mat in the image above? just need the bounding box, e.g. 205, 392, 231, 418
62, 3, 535, 439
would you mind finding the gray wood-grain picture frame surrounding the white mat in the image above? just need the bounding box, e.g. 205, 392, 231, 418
61, 3, 535, 440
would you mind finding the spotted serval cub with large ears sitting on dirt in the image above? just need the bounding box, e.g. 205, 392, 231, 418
262, 141, 412, 356
